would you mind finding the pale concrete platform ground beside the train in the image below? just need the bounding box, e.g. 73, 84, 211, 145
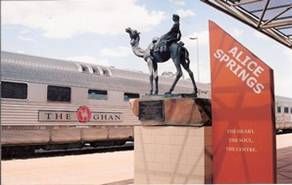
1, 134, 292, 185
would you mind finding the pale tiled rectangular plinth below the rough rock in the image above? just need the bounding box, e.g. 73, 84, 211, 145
134, 126, 212, 184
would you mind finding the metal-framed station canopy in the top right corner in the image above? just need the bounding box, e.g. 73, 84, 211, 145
201, 0, 292, 48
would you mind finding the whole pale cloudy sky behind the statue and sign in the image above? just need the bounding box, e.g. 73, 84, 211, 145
1, 0, 292, 98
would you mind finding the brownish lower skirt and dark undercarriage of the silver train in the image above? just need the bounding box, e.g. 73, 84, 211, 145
1, 126, 133, 159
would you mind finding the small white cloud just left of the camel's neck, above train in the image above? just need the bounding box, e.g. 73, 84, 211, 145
100, 46, 131, 58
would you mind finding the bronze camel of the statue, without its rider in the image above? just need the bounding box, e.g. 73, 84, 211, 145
125, 28, 197, 96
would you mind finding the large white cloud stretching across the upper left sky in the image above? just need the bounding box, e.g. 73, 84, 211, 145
1, 0, 166, 39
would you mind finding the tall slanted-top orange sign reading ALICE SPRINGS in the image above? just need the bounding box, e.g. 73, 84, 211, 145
209, 21, 276, 183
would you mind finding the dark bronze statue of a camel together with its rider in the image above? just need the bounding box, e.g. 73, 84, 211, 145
125, 14, 198, 97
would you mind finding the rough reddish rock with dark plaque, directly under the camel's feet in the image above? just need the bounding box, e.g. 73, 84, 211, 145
130, 96, 211, 126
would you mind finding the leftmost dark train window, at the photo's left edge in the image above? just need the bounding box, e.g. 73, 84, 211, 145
1, 82, 27, 99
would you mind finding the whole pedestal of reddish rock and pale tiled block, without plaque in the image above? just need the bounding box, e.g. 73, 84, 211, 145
131, 98, 212, 184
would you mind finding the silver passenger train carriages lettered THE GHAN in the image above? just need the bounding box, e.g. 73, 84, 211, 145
1, 51, 292, 154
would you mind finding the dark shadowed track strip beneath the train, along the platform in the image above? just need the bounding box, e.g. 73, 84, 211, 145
1, 142, 134, 160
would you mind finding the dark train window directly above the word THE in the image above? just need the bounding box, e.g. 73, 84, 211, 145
47, 85, 71, 102
